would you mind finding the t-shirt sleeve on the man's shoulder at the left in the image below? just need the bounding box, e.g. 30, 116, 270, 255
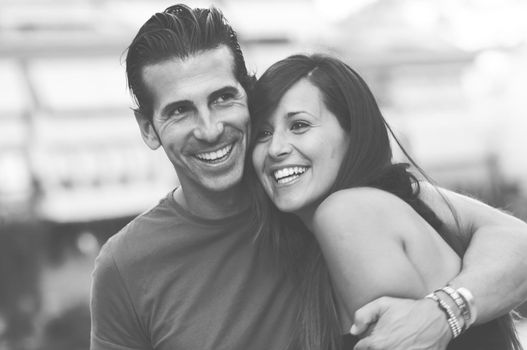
90, 239, 152, 350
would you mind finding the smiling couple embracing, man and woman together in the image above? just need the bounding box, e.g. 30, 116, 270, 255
91, 5, 527, 350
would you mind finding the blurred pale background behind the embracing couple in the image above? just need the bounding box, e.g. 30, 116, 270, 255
0, 0, 527, 350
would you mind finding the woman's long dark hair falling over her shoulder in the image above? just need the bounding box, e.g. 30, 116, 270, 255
250, 54, 520, 350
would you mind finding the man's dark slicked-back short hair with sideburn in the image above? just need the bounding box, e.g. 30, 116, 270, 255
126, 4, 254, 118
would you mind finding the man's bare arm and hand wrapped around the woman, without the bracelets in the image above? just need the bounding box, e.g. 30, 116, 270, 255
354, 184, 527, 350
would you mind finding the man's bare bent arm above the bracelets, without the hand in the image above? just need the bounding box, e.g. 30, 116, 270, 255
421, 184, 527, 324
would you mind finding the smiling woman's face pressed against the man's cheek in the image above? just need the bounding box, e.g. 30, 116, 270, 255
252, 79, 349, 215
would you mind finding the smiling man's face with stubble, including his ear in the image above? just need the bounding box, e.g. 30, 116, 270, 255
138, 46, 249, 195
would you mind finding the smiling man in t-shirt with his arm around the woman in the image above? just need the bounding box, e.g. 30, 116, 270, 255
91, 5, 527, 350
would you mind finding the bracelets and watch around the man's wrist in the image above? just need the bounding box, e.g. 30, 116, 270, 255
425, 285, 477, 338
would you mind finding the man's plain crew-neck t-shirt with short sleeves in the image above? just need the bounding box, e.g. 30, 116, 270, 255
91, 195, 297, 350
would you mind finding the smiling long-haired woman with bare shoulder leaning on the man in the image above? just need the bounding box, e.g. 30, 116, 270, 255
251, 55, 521, 349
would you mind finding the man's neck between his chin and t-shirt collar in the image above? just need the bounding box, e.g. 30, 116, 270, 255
173, 186, 249, 219
